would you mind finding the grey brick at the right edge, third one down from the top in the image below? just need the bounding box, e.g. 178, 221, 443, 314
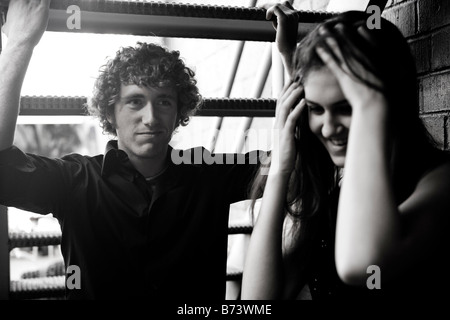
419, 72, 450, 113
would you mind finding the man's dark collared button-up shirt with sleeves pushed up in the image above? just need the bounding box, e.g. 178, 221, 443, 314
0, 141, 258, 301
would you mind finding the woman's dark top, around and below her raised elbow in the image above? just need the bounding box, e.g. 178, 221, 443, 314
307, 152, 450, 300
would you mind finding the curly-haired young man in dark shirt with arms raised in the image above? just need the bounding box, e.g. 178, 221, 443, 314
0, 0, 257, 301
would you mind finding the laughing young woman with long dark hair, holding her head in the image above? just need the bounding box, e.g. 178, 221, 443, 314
242, 5, 450, 299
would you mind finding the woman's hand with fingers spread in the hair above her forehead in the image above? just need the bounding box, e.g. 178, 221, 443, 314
316, 24, 387, 114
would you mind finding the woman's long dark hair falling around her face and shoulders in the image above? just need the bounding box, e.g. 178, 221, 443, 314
251, 11, 439, 272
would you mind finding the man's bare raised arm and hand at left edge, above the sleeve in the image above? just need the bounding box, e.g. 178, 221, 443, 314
0, 0, 50, 150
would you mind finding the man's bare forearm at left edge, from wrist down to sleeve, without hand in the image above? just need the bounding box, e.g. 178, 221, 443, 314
0, 44, 33, 150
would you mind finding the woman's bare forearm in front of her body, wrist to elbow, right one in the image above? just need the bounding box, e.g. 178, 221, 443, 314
336, 105, 399, 284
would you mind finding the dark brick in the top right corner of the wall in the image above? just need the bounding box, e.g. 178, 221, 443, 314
417, 0, 450, 33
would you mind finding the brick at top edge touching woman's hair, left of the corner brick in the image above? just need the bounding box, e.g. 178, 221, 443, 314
382, 2, 416, 37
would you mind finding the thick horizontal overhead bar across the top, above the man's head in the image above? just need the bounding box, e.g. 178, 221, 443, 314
0, 0, 334, 41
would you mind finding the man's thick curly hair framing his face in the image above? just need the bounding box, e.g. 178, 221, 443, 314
87, 42, 202, 135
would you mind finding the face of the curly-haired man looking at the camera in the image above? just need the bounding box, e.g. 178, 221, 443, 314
108, 84, 178, 160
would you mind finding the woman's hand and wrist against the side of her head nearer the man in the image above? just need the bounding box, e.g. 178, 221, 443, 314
270, 81, 305, 175
